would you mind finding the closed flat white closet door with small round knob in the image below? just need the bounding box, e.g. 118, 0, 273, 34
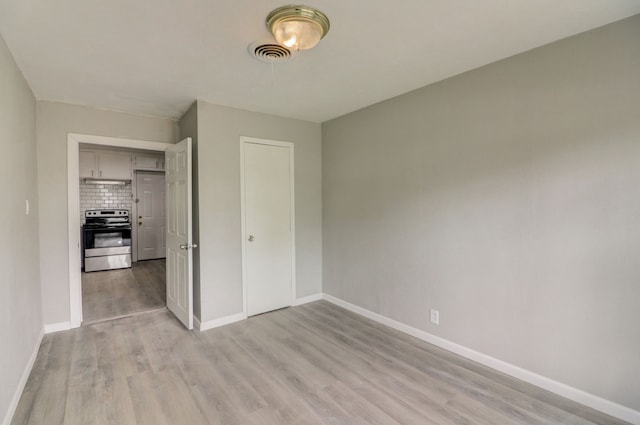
242, 139, 294, 316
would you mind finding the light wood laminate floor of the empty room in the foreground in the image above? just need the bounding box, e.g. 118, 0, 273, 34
12, 301, 623, 425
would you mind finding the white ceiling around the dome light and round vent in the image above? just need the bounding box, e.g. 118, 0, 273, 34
0, 0, 640, 122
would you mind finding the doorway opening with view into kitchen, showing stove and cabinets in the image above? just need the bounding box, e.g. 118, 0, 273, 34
79, 144, 166, 324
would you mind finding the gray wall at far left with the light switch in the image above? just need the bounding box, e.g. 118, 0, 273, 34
0, 37, 42, 423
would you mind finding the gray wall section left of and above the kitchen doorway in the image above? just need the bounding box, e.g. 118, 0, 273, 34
37, 101, 178, 324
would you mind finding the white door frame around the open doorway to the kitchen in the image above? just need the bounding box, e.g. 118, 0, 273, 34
67, 133, 173, 328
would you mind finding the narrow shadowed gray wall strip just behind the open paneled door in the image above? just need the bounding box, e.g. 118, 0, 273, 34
178, 102, 201, 320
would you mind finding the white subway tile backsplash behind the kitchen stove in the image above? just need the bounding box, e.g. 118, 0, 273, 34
80, 181, 133, 224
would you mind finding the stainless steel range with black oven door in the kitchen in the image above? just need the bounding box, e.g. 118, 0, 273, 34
82, 210, 131, 272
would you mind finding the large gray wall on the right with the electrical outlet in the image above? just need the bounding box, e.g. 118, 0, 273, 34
322, 16, 640, 410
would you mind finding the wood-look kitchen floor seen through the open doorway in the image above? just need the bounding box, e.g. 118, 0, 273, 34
82, 259, 166, 324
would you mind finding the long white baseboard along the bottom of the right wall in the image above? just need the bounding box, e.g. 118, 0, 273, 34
322, 294, 640, 425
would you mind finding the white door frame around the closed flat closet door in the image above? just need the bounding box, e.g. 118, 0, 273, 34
240, 136, 296, 317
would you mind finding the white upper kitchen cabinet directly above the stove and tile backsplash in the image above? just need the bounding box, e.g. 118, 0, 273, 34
79, 151, 133, 180
